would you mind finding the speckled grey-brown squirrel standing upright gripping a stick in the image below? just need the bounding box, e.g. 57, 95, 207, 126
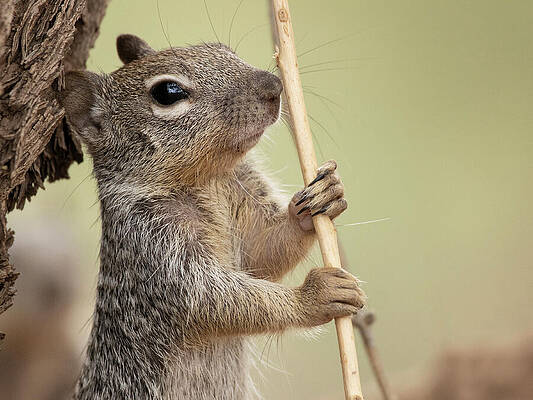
61, 35, 364, 400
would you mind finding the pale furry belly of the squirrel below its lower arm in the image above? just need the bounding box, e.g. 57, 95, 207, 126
165, 338, 256, 400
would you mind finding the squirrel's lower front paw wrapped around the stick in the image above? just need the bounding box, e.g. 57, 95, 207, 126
296, 268, 366, 327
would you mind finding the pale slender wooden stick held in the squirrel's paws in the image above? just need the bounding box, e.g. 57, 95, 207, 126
272, 0, 363, 400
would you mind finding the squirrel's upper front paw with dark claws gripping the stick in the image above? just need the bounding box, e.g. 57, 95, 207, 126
289, 160, 348, 231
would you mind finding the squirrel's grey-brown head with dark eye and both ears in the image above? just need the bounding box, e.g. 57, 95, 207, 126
62, 35, 282, 187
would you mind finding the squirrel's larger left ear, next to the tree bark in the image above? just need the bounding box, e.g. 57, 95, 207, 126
60, 71, 101, 137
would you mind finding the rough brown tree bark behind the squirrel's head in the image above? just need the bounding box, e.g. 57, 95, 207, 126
0, 0, 109, 340
